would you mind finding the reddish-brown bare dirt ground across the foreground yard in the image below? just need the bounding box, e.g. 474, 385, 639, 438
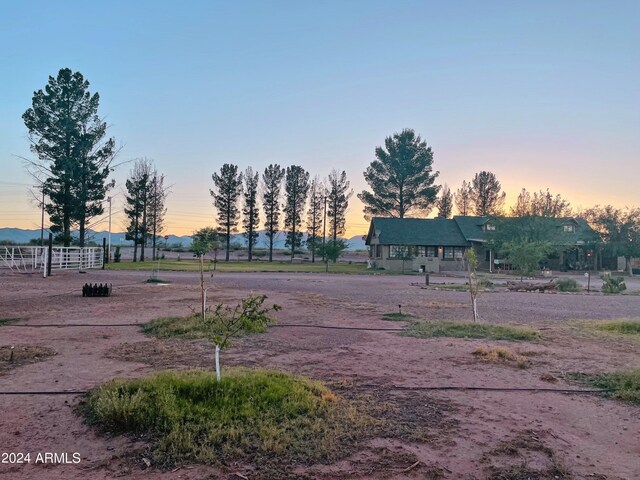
0, 271, 640, 480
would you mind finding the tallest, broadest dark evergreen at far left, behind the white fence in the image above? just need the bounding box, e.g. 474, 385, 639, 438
22, 68, 116, 247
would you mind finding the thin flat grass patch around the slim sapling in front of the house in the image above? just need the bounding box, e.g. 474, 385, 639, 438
402, 321, 540, 340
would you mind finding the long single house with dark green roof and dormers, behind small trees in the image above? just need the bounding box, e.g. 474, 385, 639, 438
365, 216, 598, 272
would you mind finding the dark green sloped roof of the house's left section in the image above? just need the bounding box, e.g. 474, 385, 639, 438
366, 217, 469, 247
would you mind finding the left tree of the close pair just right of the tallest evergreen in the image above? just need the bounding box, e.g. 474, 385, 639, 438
124, 158, 152, 262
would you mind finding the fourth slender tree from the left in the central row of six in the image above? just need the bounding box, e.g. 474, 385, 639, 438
284, 165, 309, 262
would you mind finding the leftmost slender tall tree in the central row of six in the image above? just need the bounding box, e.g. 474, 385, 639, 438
209, 163, 242, 262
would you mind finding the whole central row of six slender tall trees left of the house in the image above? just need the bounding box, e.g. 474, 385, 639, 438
210, 163, 353, 261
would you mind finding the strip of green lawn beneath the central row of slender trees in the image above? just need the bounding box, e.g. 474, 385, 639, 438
106, 259, 376, 274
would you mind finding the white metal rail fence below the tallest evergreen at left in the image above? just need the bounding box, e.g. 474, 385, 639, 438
0, 247, 104, 277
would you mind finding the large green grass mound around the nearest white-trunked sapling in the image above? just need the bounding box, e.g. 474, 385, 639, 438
81, 370, 374, 467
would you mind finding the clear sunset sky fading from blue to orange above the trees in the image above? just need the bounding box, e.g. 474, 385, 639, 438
0, 0, 640, 236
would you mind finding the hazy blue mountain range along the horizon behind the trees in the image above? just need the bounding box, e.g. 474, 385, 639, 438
0, 228, 366, 250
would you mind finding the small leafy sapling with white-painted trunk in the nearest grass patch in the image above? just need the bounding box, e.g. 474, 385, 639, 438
204, 295, 281, 382
